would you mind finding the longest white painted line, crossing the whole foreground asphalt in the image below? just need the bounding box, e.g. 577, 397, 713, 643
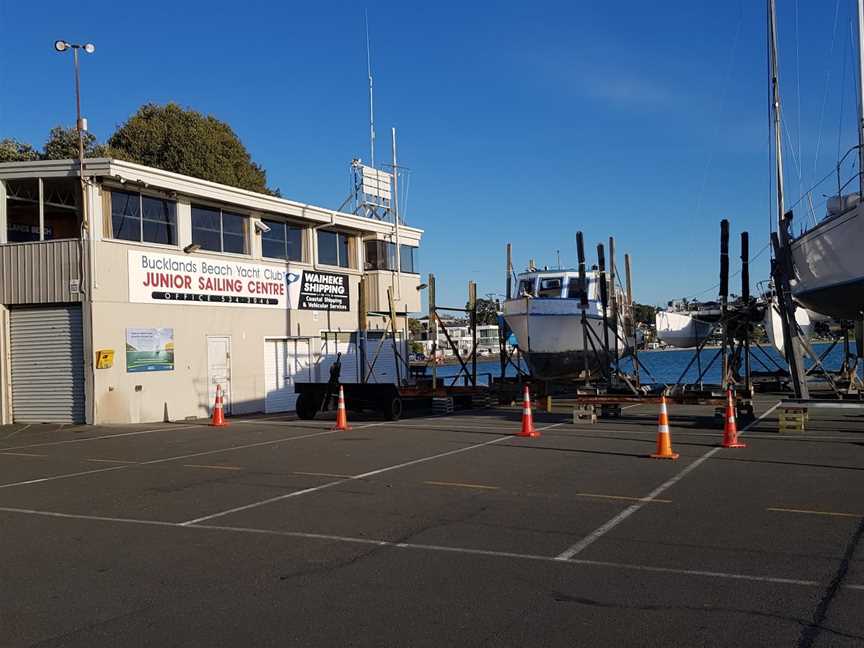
0, 507, 864, 592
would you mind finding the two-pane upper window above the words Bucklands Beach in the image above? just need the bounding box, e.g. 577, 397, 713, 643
111, 191, 177, 245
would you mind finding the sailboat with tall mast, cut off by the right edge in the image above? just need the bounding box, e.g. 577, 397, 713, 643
769, 0, 864, 320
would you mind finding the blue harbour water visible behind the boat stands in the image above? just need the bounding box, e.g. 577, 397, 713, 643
436, 344, 861, 384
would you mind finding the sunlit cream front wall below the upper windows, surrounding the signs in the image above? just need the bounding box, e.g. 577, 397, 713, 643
93, 241, 360, 423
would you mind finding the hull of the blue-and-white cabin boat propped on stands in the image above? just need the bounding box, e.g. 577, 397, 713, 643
504, 298, 625, 379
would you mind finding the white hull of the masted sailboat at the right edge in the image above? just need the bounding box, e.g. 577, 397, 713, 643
791, 204, 864, 319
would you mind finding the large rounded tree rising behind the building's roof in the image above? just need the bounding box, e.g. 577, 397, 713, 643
108, 103, 278, 194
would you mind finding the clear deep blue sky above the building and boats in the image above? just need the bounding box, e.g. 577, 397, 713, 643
0, 0, 856, 304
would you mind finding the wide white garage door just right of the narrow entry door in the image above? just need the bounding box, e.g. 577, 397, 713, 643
264, 338, 312, 413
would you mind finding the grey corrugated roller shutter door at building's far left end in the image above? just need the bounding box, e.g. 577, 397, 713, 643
9, 306, 84, 423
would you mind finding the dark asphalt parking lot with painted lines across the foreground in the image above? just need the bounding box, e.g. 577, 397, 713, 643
0, 399, 864, 647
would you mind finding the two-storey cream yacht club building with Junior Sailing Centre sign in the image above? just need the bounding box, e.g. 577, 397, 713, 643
0, 159, 422, 423
